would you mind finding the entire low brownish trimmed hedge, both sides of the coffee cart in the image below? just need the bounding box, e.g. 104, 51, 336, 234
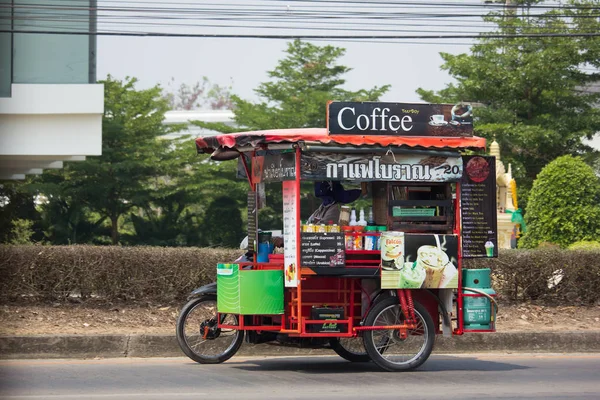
0, 245, 600, 305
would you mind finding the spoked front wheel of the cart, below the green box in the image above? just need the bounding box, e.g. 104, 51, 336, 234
177, 296, 244, 364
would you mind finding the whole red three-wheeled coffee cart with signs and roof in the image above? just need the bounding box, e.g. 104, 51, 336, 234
177, 102, 497, 371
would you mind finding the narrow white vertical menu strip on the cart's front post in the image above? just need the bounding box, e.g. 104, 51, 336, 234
283, 181, 299, 287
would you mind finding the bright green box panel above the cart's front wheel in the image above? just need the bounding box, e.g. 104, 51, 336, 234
217, 264, 283, 315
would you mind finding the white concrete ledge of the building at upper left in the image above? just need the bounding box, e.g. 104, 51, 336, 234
0, 84, 104, 179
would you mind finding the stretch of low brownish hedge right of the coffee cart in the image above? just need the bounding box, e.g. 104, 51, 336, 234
463, 247, 600, 305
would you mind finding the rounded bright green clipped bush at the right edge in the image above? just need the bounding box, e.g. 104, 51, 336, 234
519, 155, 600, 248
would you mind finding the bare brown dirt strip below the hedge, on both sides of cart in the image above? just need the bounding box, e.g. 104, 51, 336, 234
0, 302, 600, 336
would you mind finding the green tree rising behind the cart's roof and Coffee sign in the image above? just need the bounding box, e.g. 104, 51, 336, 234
193, 40, 390, 233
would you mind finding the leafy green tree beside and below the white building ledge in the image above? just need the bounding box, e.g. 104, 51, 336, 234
32, 75, 181, 244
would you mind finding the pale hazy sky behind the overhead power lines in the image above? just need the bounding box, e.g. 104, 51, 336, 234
97, 0, 489, 102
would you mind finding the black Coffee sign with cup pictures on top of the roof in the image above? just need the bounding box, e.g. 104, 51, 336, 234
327, 102, 473, 136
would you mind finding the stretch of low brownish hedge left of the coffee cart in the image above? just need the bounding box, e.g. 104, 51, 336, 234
0, 245, 240, 302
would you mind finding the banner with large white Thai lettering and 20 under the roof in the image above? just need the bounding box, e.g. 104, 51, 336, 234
300, 153, 463, 182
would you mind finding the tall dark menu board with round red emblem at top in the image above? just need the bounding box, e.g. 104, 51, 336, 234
460, 156, 498, 258
